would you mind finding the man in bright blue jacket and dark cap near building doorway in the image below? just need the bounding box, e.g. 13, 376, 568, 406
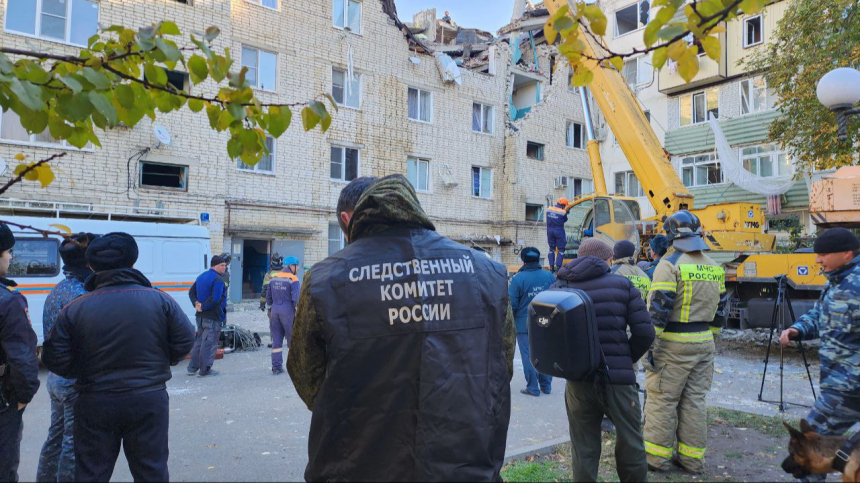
186, 255, 227, 377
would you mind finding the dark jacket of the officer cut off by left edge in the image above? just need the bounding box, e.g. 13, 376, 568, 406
0, 278, 39, 411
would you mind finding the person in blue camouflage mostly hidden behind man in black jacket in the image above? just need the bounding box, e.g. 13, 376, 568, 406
36, 233, 96, 481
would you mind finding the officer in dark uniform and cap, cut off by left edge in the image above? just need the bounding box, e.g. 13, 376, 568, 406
0, 223, 39, 481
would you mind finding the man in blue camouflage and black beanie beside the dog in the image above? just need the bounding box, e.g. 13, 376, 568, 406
779, 228, 860, 481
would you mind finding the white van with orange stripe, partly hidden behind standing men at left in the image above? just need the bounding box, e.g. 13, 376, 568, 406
0, 216, 211, 346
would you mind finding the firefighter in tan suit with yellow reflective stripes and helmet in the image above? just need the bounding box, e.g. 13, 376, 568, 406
645, 210, 726, 473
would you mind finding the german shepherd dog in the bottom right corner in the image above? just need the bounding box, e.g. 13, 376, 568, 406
782, 419, 860, 483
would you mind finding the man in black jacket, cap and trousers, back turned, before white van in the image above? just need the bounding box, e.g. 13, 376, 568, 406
42, 233, 194, 481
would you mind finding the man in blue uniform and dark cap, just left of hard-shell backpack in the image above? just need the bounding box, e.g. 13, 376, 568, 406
508, 247, 555, 396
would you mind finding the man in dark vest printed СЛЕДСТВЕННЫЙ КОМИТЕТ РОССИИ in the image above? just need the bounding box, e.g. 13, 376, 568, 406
287, 175, 516, 481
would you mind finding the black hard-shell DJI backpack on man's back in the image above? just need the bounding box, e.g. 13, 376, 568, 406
528, 288, 609, 382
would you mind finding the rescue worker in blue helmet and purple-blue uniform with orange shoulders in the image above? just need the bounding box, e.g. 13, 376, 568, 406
266, 257, 301, 376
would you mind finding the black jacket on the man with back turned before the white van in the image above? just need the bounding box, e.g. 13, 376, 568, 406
42, 269, 194, 393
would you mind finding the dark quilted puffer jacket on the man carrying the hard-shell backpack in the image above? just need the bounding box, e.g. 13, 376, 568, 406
553, 257, 655, 384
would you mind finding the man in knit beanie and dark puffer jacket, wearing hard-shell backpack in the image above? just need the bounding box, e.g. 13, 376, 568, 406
553, 238, 655, 482
